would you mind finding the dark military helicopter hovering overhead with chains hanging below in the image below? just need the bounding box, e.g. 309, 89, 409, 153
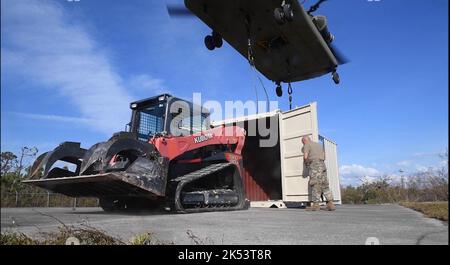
167, 0, 347, 97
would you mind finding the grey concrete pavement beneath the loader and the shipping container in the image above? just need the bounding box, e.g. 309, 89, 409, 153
1, 205, 448, 245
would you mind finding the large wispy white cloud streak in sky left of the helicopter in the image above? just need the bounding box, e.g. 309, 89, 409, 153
1, 0, 162, 134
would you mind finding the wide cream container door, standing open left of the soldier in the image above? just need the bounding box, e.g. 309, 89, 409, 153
279, 102, 319, 202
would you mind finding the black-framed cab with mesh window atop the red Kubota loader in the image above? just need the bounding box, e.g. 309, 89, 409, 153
130, 94, 210, 142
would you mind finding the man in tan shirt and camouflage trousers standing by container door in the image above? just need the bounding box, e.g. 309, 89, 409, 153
302, 136, 336, 211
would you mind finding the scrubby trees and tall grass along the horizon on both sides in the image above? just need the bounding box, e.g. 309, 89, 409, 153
1, 147, 448, 205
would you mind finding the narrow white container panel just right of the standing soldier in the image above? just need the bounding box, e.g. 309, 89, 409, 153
320, 137, 341, 204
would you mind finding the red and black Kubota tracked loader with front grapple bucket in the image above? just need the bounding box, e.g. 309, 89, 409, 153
24, 94, 249, 213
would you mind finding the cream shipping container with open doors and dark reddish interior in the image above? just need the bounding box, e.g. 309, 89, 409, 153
212, 102, 341, 207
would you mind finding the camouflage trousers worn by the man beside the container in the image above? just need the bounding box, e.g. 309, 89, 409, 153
308, 160, 333, 203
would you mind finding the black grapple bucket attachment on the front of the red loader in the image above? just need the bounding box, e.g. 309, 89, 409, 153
24, 133, 168, 198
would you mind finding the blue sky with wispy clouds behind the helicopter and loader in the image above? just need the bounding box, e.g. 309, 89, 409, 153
1, 0, 448, 184
